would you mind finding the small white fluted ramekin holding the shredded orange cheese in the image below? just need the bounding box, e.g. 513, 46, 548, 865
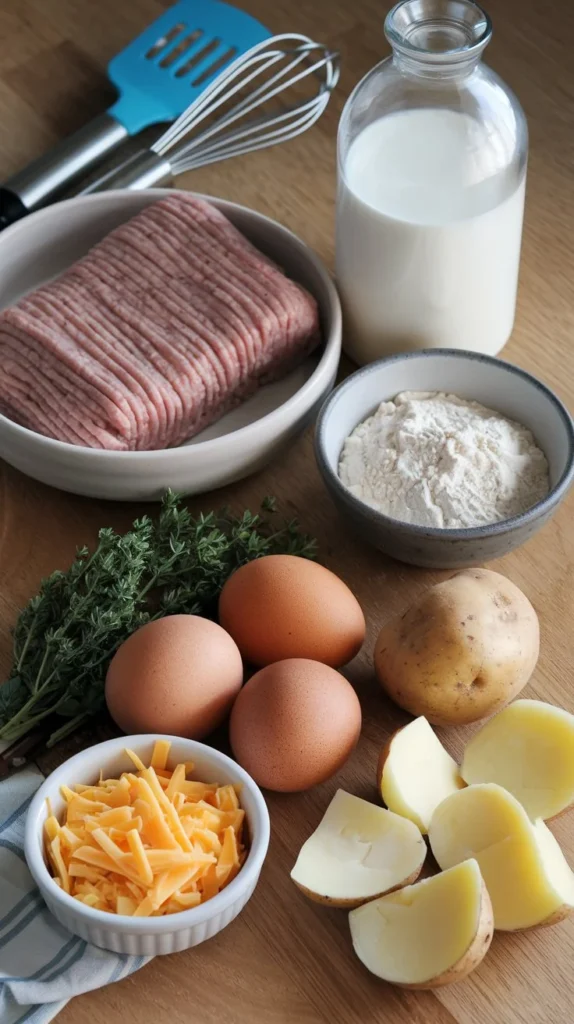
25, 735, 269, 956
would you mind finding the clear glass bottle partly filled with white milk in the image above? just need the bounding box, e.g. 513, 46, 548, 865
337, 0, 528, 364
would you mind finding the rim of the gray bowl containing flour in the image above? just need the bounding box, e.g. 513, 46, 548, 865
315, 348, 574, 541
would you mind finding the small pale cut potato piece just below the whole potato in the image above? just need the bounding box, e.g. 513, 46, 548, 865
378, 717, 465, 835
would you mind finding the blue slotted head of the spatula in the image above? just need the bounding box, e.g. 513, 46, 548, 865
107, 0, 271, 135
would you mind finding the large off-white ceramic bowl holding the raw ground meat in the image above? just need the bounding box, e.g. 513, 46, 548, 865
0, 188, 342, 501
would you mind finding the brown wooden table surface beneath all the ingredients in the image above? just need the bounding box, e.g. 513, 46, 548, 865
0, 0, 574, 1024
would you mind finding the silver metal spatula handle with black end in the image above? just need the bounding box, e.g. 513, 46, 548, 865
0, 114, 128, 229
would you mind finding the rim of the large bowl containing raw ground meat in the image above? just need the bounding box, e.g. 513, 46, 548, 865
0, 188, 343, 463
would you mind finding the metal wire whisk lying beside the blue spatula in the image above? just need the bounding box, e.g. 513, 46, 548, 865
80, 33, 339, 195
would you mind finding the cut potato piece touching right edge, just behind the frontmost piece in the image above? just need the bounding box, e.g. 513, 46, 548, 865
429, 782, 574, 931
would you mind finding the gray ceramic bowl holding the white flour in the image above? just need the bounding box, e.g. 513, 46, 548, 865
315, 349, 574, 568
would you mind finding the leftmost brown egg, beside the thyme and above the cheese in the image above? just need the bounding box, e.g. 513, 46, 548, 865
105, 615, 244, 739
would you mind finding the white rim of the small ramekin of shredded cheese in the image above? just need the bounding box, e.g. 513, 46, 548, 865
24, 733, 270, 934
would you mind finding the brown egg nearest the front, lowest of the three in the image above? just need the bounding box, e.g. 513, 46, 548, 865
229, 657, 361, 793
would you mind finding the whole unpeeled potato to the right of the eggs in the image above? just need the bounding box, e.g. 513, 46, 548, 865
374, 569, 539, 725
